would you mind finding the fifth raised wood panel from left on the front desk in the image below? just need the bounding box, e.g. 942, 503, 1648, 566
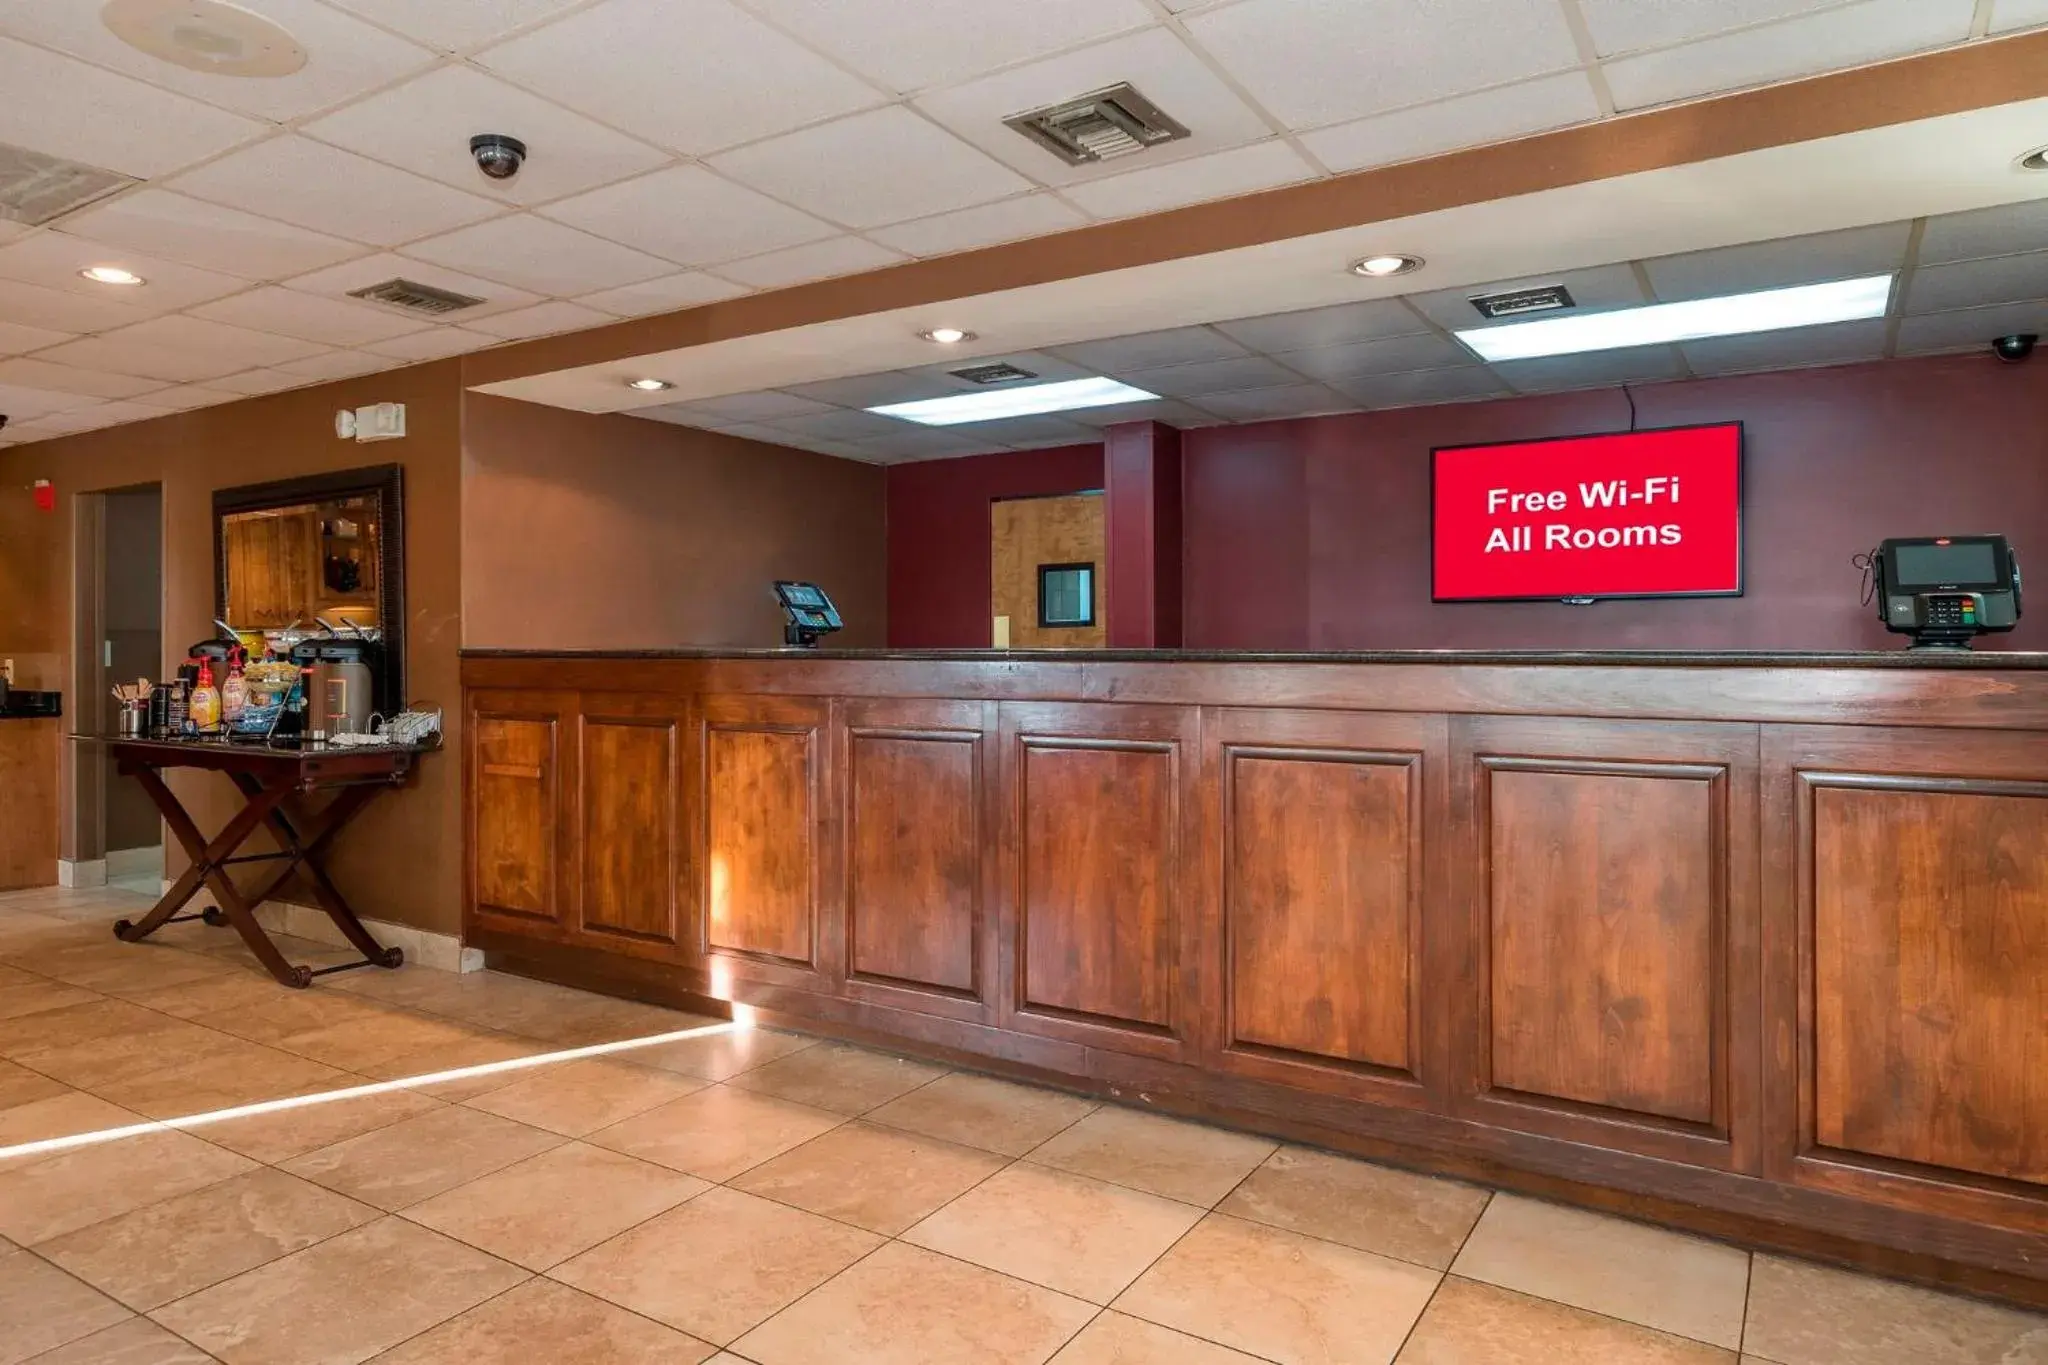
999, 704, 1196, 1058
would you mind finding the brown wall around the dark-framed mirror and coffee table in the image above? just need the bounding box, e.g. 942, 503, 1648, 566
0, 360, 461, 933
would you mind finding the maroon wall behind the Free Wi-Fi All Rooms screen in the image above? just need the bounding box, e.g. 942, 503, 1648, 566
1187, 356, 2048, 649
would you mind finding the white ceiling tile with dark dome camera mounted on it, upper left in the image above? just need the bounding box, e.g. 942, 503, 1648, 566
305, 65, 670, 205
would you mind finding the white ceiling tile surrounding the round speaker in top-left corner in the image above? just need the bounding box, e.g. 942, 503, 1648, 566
0, 0, 434, 121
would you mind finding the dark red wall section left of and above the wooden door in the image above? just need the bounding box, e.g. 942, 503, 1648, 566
889, 446, 1102, 649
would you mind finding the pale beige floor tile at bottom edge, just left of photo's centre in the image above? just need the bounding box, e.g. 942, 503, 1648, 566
733, 1242, 1094, 1365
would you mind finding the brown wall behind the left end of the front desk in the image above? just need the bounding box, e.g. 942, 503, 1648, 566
463, 393, 887, 649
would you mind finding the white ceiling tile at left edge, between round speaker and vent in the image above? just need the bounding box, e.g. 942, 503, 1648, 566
0, 35, 266, 178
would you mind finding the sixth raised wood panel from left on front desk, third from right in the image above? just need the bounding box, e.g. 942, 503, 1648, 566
1204, 710, 1446, 1103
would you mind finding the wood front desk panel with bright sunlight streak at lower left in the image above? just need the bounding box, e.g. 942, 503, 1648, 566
702, 696, 829, 972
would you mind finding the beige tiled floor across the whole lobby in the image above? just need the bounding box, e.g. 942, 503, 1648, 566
0, 890, 2048, 1365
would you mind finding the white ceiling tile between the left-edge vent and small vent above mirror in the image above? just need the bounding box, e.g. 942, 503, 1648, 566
63, 188, 369, 280
